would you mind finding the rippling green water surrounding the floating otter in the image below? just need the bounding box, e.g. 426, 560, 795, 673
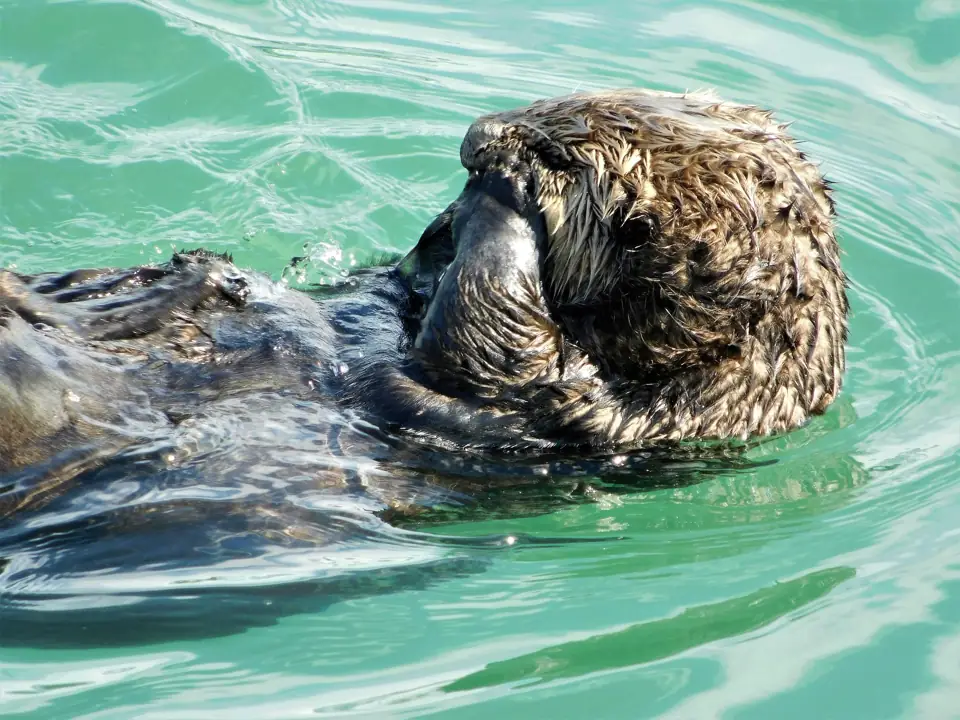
0, 0, 960, 720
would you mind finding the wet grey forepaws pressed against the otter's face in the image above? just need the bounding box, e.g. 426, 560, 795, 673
402, 169, 560, 397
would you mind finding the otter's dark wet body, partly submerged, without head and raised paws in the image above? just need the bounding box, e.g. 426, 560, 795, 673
0, 252, 764, 646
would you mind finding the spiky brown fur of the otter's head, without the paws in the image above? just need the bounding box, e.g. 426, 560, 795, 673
461, 91, 848, 444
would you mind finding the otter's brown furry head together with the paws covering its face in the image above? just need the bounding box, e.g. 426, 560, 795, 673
404, 91, 847, 444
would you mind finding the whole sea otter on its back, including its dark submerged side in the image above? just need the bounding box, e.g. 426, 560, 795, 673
0, 90, 847, 643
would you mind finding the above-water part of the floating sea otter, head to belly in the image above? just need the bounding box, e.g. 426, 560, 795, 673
0, 90, 847, 512
